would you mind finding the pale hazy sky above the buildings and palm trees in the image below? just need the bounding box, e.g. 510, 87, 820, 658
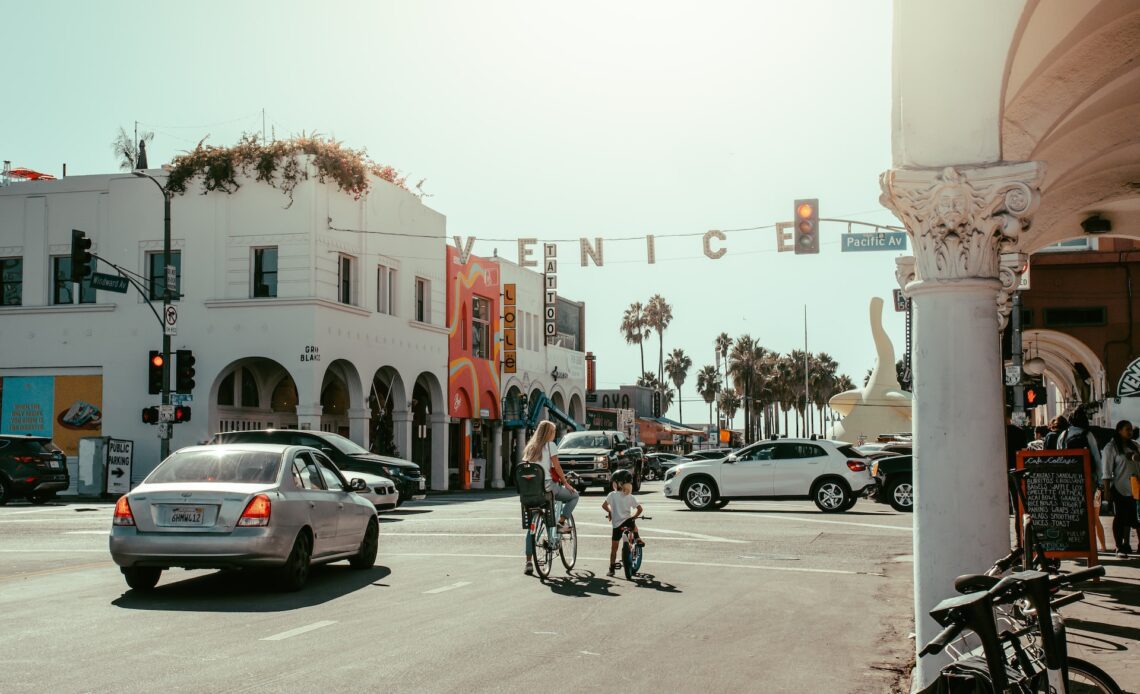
0, 0, 904, 422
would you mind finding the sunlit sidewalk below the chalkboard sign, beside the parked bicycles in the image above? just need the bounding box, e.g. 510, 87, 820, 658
1064, 549, 1140, 693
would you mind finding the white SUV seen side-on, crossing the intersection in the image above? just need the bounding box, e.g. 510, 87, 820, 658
665, 439, 876, 513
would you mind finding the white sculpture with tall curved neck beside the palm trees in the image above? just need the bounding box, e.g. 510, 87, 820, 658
830, 296, 912, 443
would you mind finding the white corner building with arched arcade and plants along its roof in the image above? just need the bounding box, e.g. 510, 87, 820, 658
0, 165, 448, 489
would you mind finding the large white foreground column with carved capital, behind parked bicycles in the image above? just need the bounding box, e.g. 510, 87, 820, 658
880, 162, 1044, 688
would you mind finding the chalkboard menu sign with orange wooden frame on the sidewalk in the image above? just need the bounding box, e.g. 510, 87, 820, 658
1017, 449, 1097, 565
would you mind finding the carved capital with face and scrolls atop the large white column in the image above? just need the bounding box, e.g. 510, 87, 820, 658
879, 162, 1045, 281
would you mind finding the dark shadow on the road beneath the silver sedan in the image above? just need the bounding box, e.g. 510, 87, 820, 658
111, 565, 392, 612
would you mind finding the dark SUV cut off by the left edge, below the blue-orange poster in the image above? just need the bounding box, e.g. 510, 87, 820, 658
0, 434, 71, 506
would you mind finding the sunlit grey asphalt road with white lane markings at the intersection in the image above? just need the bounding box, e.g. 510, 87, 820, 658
0, 483, 912, 693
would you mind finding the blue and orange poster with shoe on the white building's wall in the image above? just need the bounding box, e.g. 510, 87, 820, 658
0, 375, 103, 457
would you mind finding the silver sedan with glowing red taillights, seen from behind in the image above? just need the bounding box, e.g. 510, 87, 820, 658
109, 444, 380, 590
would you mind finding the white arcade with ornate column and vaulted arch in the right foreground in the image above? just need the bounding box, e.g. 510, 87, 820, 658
880, 0, 1140, 687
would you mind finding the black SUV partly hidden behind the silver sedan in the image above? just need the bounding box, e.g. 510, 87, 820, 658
210, 428, 426, 506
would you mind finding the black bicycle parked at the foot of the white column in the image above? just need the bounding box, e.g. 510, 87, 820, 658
919, 565, 1121, 694
